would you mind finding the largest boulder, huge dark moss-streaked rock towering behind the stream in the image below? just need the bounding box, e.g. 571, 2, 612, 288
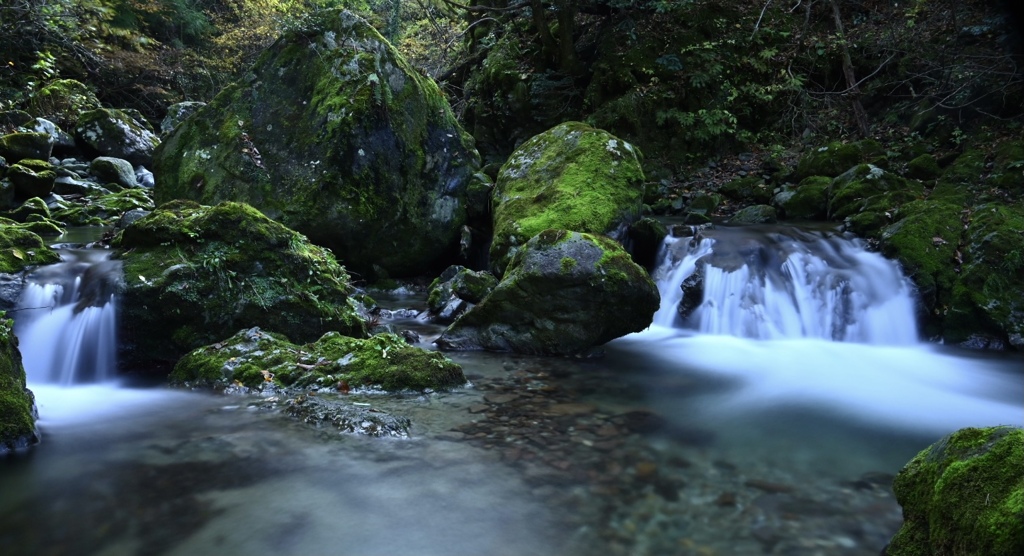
154, 10, 479, 277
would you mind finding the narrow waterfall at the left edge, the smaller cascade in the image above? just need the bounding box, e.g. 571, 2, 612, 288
14, 249, 121, 385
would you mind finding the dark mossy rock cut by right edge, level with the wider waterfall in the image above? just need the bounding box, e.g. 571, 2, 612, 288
943, 203, 1024, 350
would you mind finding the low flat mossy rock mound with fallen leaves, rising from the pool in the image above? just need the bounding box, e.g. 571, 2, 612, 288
171, 328, 466, 391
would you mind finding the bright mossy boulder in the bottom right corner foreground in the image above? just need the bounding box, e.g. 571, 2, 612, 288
884, 427, 1024, 556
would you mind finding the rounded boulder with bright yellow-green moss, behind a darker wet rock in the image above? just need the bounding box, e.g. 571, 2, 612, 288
490, 122, 644, 274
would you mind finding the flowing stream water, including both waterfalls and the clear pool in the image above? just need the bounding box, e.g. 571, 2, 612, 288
0, 228, 1024, 556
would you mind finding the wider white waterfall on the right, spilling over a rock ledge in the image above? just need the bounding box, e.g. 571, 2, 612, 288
653, 226, 918, 344
